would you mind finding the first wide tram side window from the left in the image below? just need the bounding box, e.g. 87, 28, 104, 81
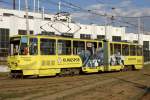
40, 39, 56, 55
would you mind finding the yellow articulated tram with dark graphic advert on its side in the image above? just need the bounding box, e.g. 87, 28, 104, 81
8, 35, 143, 77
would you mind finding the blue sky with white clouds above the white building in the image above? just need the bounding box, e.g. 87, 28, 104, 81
0, 0, 150, 31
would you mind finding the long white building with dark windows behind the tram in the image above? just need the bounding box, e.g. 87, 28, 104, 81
0, 8, 150, 61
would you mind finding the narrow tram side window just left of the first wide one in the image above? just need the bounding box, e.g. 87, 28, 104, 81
29, 38, 38, 55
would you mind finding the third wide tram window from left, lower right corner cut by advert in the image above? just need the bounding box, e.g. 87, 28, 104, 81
73, 41, 85, 55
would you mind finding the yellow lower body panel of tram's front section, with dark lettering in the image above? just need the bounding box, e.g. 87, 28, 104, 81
8, 55, 82, 76
